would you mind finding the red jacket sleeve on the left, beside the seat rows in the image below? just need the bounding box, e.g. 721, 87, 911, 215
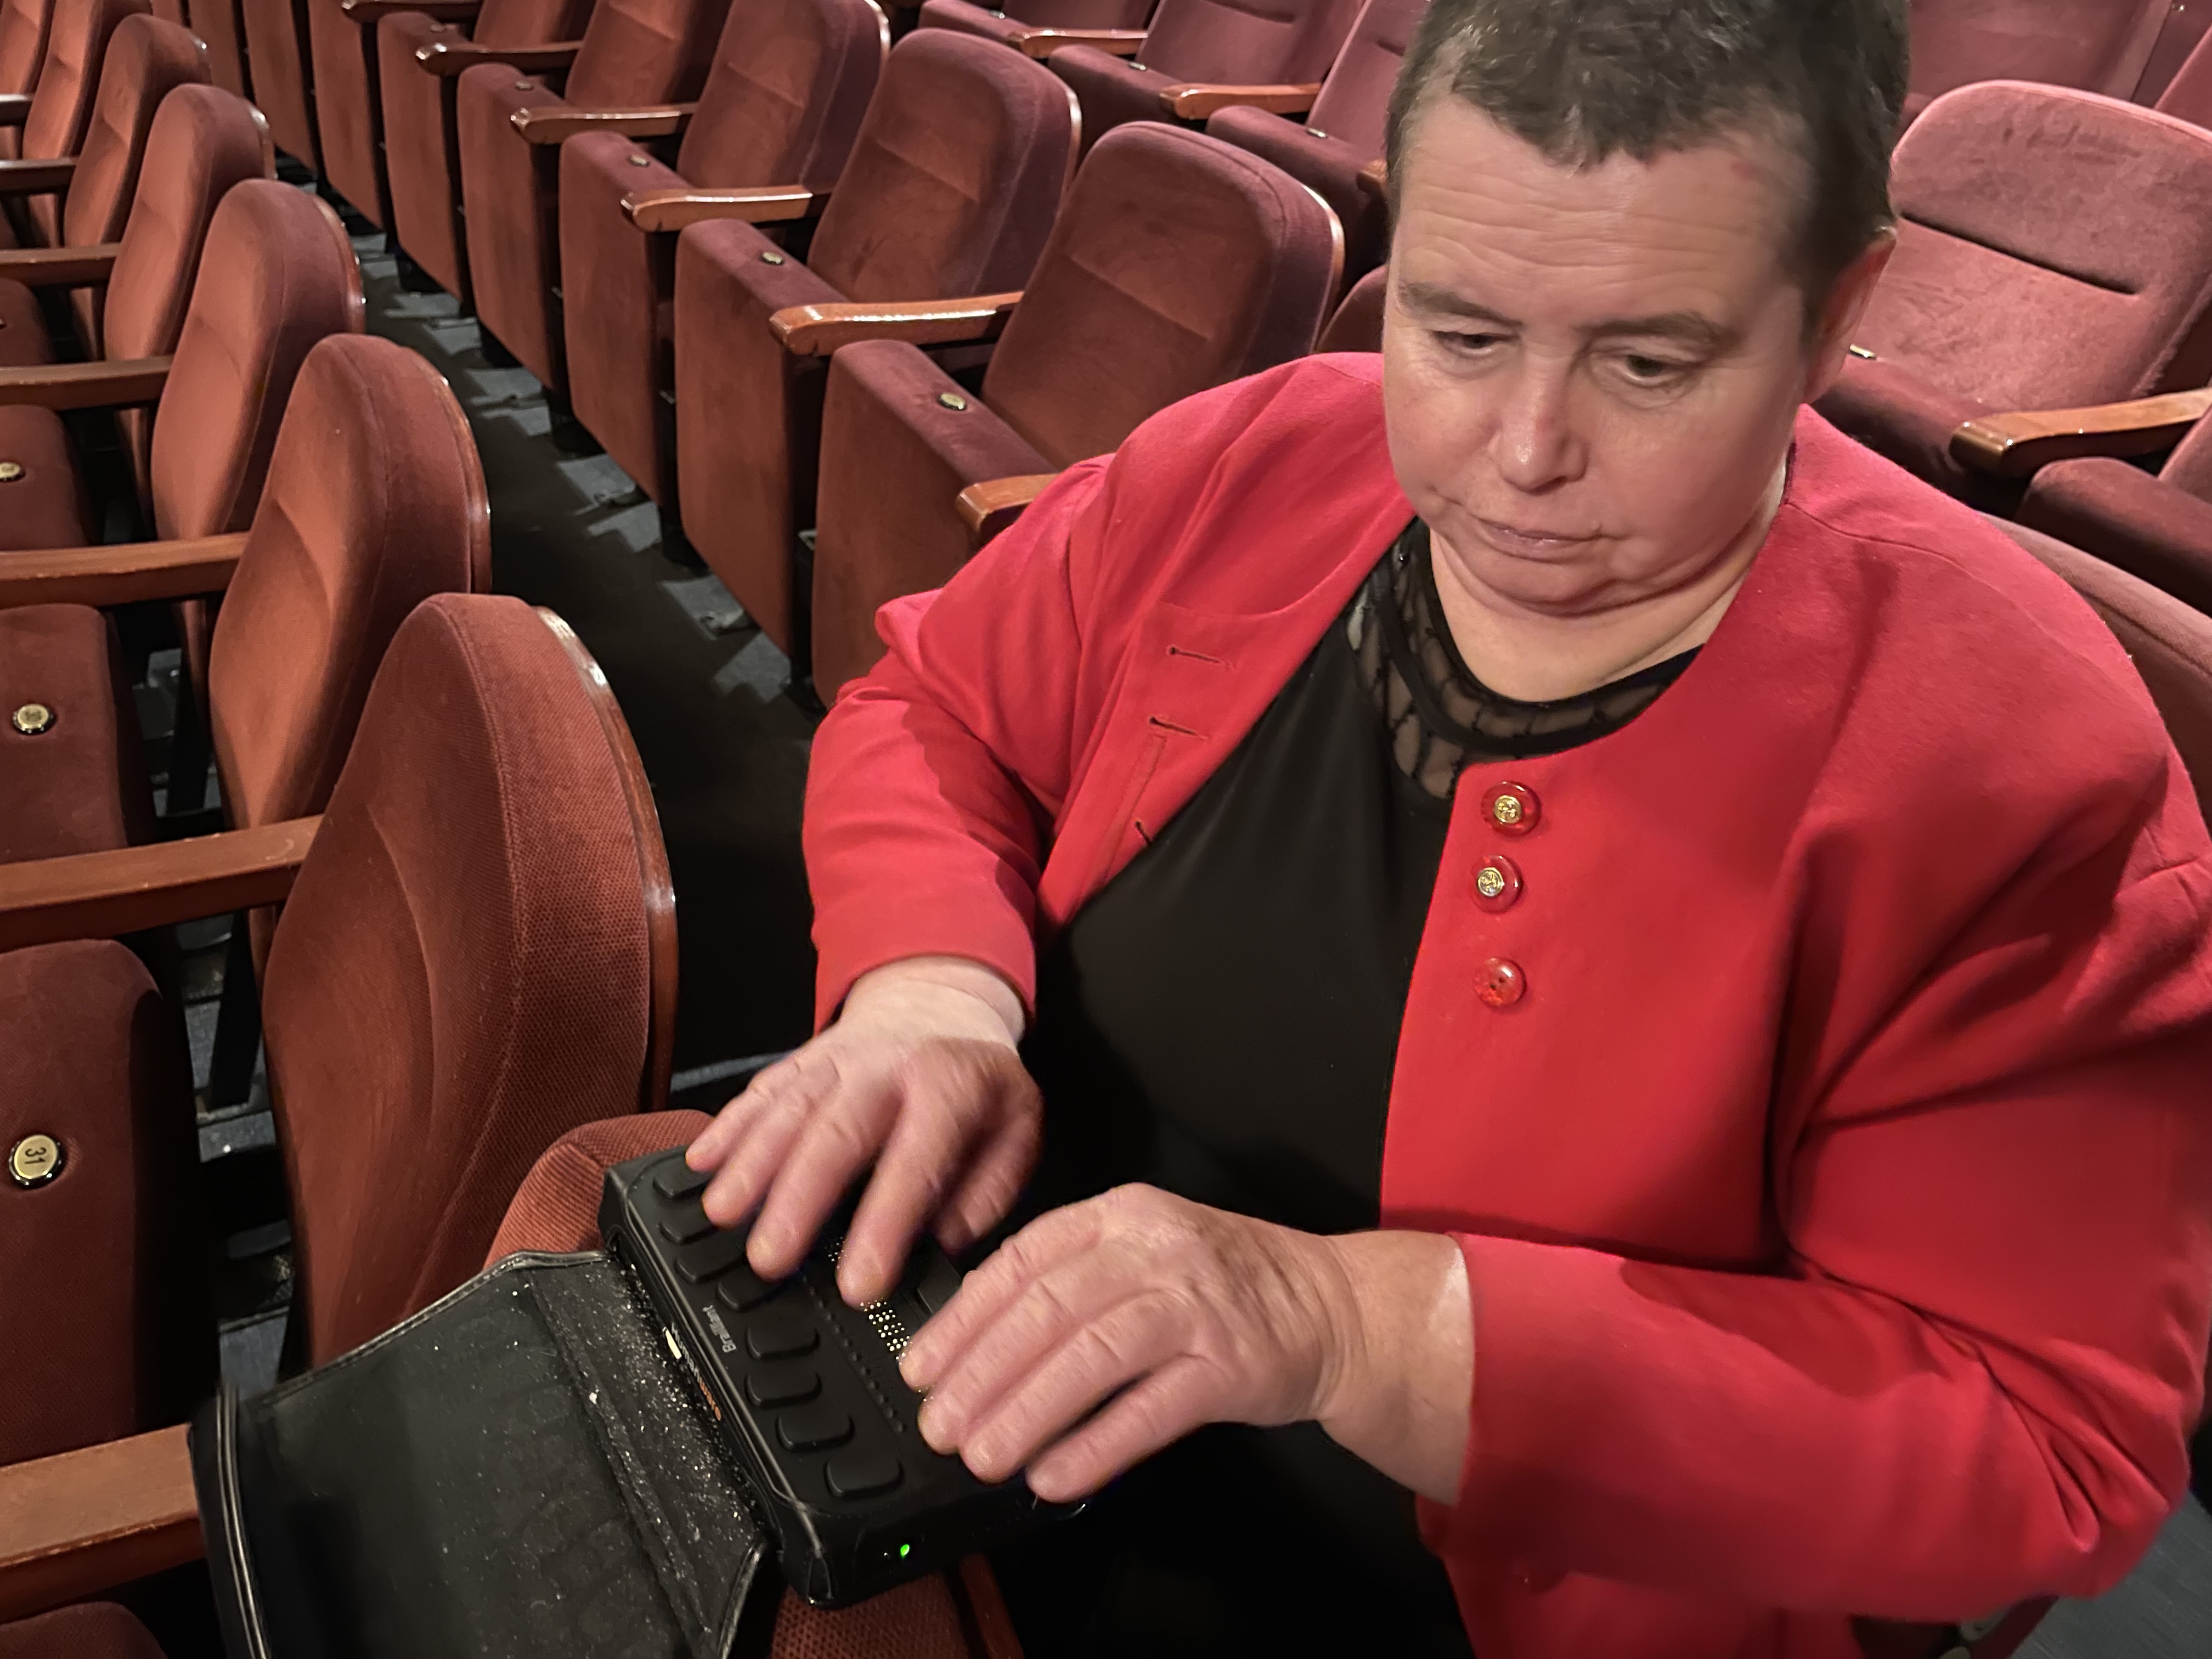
805, 458, 1108, 1029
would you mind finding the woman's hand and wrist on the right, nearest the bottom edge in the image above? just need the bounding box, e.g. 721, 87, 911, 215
900, 1186, 1471, 1502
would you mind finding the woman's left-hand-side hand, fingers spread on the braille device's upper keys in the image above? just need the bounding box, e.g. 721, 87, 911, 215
686, 956, 1042, 1307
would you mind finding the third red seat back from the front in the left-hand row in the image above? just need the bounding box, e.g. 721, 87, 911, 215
150, 179, 363, 535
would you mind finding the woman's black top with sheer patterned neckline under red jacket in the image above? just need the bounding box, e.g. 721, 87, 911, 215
1000, 522, 1690, 1659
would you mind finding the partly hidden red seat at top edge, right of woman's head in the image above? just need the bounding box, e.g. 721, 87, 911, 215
1905, 0, 2176, 122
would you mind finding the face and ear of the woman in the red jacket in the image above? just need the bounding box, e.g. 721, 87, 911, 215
1383, 95, 1887, 617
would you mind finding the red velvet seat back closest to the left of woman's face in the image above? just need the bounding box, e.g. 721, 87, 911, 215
982, 122, 1342, 467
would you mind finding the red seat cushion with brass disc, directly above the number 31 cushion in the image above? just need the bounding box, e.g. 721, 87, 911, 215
0, 604, 153, 862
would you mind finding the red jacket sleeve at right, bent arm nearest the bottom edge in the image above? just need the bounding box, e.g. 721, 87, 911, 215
1423, 761, 2212, 1621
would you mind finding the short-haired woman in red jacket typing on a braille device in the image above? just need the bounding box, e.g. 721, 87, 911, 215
502, 0, 2212, 1659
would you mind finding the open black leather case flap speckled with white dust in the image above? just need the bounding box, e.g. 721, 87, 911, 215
193, 1254, 783, 1659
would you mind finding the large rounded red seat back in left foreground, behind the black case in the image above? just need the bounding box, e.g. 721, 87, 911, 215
261, 595, 673, 1363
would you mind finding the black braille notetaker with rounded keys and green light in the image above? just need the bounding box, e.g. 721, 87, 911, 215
600, 1148, 1075, 1608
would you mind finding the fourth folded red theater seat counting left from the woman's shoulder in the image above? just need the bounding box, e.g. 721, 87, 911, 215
454, 0, 725, 392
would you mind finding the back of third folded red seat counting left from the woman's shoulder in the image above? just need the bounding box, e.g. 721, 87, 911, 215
668, 0, 891, 191
